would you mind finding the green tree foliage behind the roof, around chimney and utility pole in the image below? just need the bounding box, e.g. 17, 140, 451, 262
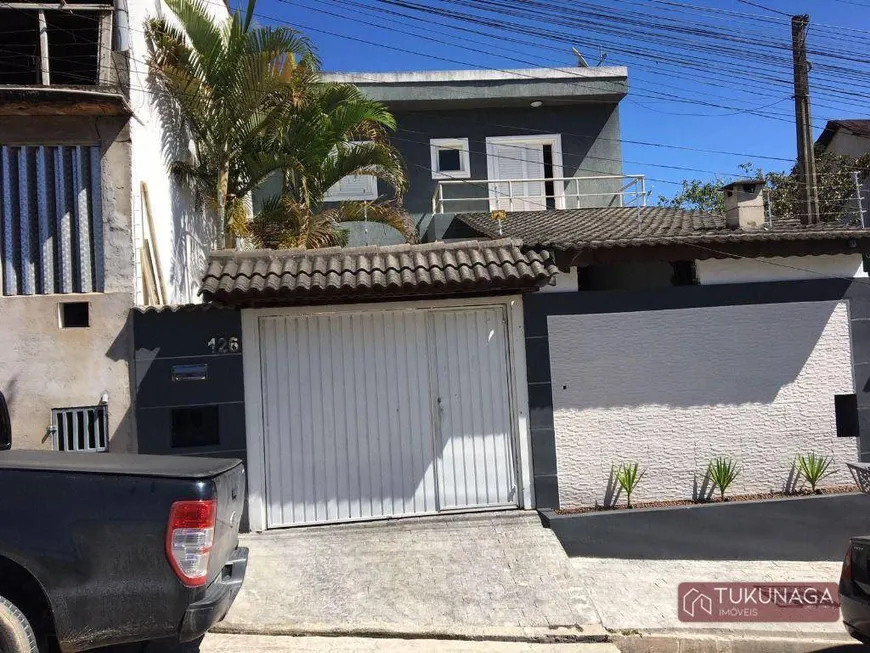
659, 146, 870, 222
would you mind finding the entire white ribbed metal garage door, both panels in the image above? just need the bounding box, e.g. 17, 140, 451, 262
259, 307, 517, 527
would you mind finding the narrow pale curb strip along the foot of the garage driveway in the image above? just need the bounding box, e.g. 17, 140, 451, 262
210, 623, 611, 644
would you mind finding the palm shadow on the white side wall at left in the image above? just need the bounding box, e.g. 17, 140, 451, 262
148, 67, 219, 303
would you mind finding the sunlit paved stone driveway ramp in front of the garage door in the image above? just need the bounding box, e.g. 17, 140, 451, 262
218, 511, 600, 637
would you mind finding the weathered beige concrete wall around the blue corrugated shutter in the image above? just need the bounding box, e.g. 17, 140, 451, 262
0, 116, 134, 451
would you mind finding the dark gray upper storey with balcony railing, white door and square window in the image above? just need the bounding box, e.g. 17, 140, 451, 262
325, 67, 643, 250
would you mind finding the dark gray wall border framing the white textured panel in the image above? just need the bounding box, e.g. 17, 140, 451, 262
523, 279, 870, 508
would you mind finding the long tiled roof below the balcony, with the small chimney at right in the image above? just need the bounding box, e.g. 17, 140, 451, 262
456, 206, 870, 252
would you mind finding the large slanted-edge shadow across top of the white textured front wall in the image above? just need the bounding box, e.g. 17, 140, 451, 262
549, 302, 851, 410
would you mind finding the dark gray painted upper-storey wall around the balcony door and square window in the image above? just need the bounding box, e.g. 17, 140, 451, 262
351, 103, 623, 245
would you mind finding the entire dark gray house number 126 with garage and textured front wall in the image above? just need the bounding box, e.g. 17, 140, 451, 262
134, 69, 870, 530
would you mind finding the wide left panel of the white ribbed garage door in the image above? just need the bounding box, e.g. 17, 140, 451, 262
260, 313, 436, 526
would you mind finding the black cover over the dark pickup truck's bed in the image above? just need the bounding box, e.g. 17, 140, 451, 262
0, 449, 242, 479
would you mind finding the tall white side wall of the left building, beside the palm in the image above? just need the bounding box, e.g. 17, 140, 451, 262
127, 0, 229, 303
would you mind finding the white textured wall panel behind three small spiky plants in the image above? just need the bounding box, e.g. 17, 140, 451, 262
548, 302, 858, 507
